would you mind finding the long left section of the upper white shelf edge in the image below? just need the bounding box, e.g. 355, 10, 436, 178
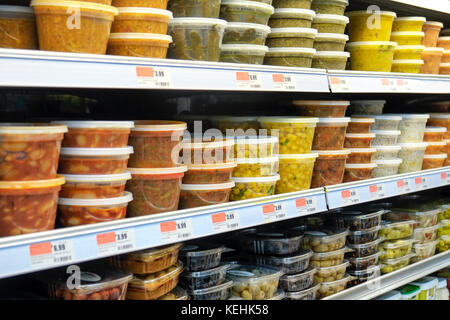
0, 49, 330, 92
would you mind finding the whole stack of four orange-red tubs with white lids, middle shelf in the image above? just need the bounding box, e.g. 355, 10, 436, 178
54, 121, 134, 227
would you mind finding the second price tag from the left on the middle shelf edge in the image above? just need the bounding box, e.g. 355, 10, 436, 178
97, 229, 136, 255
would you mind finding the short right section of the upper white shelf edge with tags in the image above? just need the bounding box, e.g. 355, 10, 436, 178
328, 70, 450, 94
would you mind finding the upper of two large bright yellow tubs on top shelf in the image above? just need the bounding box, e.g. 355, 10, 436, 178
346, 10, 396, 42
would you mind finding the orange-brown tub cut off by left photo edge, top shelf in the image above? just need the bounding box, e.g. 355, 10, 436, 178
0, 5, 37, 50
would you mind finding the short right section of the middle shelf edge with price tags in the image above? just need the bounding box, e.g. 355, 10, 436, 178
325, 167, 450, 209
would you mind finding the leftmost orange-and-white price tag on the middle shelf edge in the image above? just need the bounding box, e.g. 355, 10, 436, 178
29, 240, 75, 268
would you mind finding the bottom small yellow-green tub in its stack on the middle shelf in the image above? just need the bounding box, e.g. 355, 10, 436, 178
230, 174, 280, 201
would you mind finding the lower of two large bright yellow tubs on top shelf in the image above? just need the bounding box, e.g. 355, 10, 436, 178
347, 41, 397, 72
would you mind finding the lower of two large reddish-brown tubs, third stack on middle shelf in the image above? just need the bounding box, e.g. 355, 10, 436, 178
126, 166, 187, 217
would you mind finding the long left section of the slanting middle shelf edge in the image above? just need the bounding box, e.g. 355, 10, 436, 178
0, 188, 327, 279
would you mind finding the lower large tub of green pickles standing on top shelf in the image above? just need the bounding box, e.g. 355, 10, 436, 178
168, 18, 227, 62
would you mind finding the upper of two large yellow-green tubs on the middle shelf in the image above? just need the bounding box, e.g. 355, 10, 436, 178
258, 117, 319, 154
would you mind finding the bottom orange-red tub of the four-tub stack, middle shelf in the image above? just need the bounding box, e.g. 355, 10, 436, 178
58, 191, 133, 227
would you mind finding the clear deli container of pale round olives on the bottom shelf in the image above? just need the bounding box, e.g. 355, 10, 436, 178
227, 264, 283, 300
